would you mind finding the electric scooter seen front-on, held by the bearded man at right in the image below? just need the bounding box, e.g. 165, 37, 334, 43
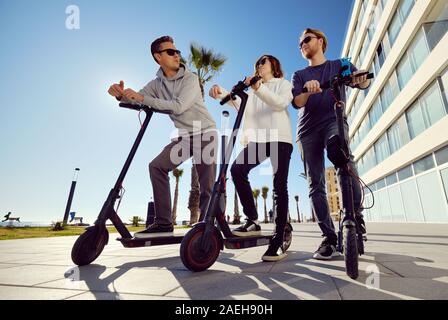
302, 58, 374, 279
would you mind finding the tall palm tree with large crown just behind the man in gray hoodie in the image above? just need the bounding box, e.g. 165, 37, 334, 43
182, 43, 227, 224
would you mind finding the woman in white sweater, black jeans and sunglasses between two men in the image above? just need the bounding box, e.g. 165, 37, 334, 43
209, 55, 293, 261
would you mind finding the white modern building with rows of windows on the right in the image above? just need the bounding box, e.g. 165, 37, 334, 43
342, 0, 448, 223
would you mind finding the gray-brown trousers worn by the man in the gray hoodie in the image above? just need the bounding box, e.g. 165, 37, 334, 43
149, 131, 218, 225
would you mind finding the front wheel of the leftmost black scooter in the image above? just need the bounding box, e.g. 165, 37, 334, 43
72, 226, 109, 266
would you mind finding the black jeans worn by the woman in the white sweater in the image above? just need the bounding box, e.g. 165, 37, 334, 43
230, 142, 293, 245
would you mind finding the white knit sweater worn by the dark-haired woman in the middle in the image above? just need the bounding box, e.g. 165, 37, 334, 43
218, 78, 293, 145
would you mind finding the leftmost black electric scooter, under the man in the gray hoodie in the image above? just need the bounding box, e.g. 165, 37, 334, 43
72, 103, 183, 266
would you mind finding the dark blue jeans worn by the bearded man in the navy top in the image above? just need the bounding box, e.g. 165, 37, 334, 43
299, 121, 362, 243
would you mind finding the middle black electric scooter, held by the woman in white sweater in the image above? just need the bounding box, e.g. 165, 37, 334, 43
180, 77, 292, 271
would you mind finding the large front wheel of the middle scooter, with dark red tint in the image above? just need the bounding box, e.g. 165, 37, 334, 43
180, 223, 222, 272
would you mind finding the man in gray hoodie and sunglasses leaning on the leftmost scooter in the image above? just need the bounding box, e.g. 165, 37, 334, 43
109, 36, 218, 237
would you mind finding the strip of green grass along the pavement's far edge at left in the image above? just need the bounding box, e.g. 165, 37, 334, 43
0, 226, 188, 240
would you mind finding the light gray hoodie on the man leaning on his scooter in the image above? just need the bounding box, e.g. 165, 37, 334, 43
123, 64, 216, 135
